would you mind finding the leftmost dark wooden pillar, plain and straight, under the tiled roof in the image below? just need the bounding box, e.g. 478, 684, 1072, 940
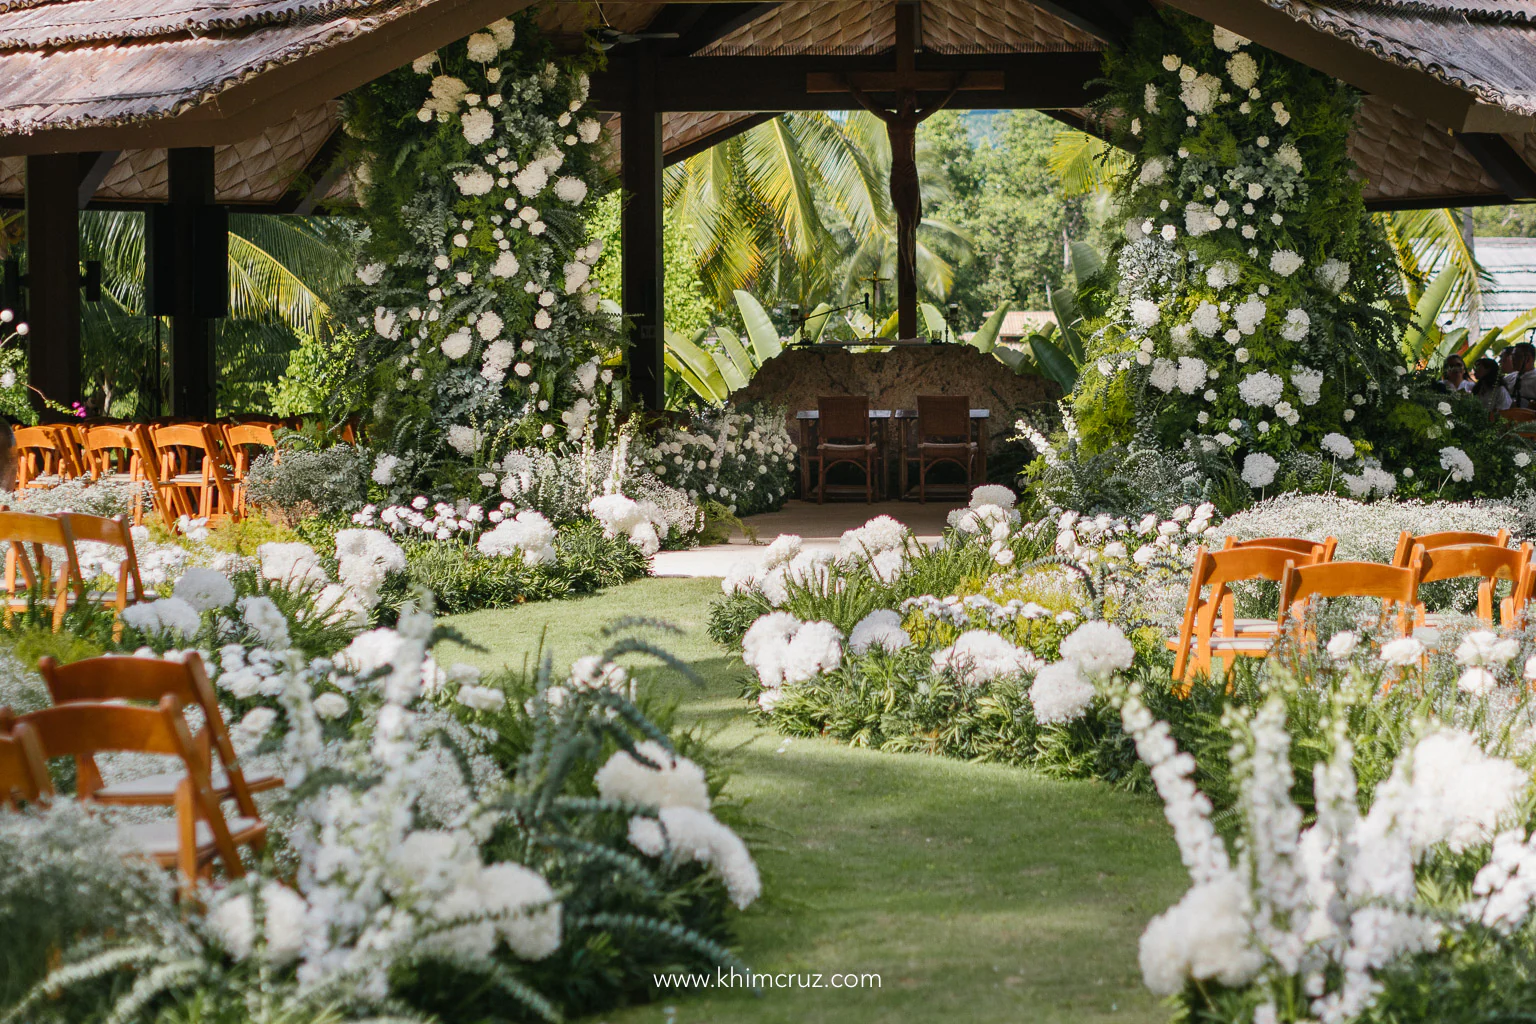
26, 154, 81, 418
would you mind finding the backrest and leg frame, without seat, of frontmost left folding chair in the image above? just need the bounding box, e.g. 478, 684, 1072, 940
17, 696, 244, 880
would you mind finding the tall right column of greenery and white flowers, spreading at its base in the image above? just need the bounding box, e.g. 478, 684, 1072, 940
1069, 15, 1513, 497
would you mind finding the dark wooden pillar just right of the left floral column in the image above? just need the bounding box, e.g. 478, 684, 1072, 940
619, 48, 667, 410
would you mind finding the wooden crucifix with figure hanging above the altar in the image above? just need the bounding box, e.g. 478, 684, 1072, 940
805, 0, 1003, 339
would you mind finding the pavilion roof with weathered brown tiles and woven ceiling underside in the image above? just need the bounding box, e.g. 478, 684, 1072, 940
0, 0, 1536, 212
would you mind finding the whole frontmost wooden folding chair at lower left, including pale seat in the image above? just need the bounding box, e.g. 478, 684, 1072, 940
12, 695, 267, 890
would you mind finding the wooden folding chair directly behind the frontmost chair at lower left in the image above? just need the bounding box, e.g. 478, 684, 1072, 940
37, 651, 283, 818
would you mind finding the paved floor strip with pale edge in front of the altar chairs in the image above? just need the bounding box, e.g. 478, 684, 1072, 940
654, 500, 965, 576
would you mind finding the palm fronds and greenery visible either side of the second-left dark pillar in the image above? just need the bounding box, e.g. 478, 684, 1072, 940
80, 210, 350, 416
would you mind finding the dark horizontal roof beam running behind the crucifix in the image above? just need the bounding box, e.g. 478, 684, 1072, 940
588, 52, 1101, 114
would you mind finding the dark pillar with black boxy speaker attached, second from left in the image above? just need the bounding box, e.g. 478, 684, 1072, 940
155, 146, 229, 419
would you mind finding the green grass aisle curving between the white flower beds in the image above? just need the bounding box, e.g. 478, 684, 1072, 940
439, 579, 1186, 1024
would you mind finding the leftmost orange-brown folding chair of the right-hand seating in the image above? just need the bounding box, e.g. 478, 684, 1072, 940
1167, 543, 1332, 682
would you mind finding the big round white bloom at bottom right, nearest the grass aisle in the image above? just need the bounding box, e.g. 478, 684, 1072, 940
1140, 870, 1264, 996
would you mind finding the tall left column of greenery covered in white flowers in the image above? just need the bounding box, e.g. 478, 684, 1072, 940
344, 18, 622, 494
